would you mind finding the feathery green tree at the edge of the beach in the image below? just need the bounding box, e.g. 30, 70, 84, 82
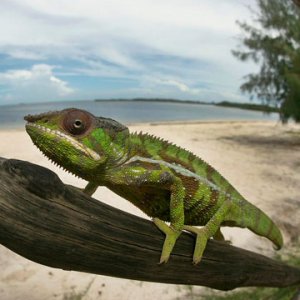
232, 0, 300, 121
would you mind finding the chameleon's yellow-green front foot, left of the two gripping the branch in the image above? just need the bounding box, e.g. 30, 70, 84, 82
153, 218, 181, 264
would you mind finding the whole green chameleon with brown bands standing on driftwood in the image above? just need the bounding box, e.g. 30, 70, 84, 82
24, 108, 283, 264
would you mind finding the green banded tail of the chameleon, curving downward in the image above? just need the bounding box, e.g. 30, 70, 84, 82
231, 201, 283, 250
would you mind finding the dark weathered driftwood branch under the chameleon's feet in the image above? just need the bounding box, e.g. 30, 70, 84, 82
0, 158, 300, 290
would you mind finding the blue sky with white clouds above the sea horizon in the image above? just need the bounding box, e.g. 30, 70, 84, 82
0, 0, 258, 105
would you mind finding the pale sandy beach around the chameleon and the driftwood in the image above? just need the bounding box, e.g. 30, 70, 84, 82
0, 121, 300, 300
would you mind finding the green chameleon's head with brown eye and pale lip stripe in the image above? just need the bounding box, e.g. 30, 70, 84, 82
24, 108, 129, 180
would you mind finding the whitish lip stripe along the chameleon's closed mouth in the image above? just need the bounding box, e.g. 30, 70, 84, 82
26, 122, 101, 161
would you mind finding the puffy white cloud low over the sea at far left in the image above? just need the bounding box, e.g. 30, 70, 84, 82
0, 64, 74, 102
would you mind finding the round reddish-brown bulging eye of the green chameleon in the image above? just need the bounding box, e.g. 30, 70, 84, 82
63, 110, 92, 135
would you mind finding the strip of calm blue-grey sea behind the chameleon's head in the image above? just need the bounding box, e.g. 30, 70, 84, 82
0, 100, 278, 128
